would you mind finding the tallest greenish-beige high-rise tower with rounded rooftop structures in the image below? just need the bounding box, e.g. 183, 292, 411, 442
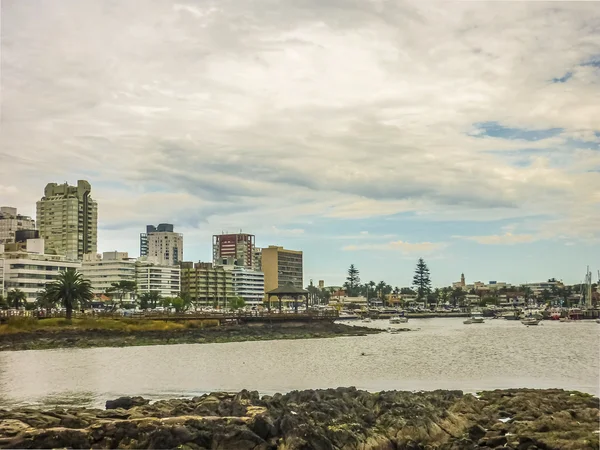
37, 180, 98, 260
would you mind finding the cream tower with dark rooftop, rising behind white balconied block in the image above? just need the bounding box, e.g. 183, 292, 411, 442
140, 223, 183, 266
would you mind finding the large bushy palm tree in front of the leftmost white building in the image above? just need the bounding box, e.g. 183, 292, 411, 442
46, 268, 94, 320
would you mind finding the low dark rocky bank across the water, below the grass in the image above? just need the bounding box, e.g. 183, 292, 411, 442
0, 322, 382, 351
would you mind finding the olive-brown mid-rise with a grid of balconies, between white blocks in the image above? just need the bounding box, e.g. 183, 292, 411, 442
181, 262, 235, 308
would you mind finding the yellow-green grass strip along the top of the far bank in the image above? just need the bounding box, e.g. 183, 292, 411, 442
0, 317, 218, 334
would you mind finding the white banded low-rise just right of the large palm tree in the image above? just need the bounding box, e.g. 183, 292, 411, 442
81, 252, 136, 301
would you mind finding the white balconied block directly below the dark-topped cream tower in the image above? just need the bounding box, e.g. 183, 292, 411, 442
135, 258, 181, 297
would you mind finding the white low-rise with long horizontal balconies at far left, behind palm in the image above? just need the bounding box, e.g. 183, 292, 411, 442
0, 239, 81, 302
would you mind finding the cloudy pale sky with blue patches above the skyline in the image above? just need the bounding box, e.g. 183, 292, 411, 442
0, 0, 600, 286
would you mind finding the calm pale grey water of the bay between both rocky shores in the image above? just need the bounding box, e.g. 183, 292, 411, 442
0, 319, 600, 407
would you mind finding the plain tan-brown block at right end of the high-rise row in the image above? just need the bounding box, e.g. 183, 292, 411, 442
262, 245, 304, 292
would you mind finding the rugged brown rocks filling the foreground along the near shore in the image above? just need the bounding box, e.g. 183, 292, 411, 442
0, 388, 599, 450
